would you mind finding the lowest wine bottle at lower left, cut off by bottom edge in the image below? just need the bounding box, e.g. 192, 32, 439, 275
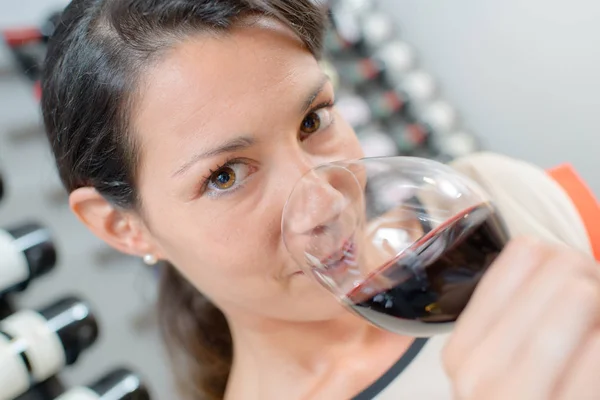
55, 368, 150, 400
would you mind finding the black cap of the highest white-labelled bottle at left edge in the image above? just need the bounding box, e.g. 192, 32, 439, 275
6, 223, 57, 290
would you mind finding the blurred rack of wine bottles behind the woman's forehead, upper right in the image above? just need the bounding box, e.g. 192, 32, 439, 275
323, 0, 479, 162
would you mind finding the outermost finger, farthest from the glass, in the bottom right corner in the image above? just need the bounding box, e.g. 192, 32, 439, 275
553, 331, 600, 400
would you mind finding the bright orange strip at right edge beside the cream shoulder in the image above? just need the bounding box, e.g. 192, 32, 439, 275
548, 164, 600, 261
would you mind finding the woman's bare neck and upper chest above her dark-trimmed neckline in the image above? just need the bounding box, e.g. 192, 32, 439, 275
226, 313, 413, 399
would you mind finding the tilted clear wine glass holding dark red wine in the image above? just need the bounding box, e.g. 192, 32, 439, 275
282, 157, 508, 337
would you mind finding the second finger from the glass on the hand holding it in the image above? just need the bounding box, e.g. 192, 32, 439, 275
448, 248, 574, 398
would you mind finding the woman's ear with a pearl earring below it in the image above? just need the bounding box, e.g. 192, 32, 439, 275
69, 187, 162, 259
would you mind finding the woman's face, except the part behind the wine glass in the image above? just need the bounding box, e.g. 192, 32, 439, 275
133, 21, 362, 321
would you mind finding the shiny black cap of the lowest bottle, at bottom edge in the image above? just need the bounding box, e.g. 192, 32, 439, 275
89, 368, 150, 400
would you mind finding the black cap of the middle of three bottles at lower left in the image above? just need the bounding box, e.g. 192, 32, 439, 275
40, 296, 99, 365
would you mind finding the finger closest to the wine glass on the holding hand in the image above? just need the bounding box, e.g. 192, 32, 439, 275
444, 238, 549, 377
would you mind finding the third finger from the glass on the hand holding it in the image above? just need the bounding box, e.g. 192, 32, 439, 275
496, 276, 600, 400
